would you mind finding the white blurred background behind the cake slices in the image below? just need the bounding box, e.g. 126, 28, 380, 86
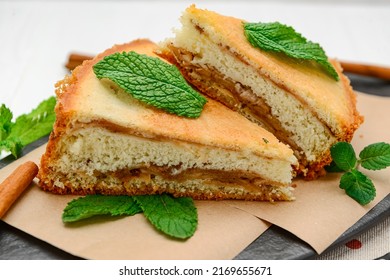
0, 0, 390, 116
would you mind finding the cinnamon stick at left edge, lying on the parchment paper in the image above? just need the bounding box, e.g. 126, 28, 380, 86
0, 161, 38, 218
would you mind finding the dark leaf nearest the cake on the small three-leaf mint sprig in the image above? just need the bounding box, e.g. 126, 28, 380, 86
330, 142, 357, 171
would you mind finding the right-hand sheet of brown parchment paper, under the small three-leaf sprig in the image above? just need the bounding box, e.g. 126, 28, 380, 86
227, 93, 390, 253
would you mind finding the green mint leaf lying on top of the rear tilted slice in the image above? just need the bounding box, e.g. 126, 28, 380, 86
244, 22, 339, 81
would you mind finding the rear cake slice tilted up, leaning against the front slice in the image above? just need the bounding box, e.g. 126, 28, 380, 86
160, 5, 363, 179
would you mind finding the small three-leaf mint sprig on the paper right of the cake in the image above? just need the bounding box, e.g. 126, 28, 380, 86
327, 142, 390, 205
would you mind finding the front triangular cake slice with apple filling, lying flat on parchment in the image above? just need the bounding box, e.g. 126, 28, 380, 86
38, 40, 296, 201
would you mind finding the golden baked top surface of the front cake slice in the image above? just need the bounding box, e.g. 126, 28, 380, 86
54, 40, 296, 164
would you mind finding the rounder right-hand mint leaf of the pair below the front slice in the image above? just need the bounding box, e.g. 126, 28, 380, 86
134, 194, 198, 239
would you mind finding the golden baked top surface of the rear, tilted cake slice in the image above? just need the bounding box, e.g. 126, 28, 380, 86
182, 5, 362, 138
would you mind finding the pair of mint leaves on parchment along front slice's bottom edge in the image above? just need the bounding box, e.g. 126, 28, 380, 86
62, 194, 198, 239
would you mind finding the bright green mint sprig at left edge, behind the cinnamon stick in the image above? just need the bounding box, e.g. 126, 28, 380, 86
0, 96, 56, 158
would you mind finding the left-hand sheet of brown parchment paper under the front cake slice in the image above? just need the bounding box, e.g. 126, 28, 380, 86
0, 146, 270, 260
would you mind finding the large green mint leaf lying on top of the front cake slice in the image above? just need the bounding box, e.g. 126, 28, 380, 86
93, 51, 207, 118
